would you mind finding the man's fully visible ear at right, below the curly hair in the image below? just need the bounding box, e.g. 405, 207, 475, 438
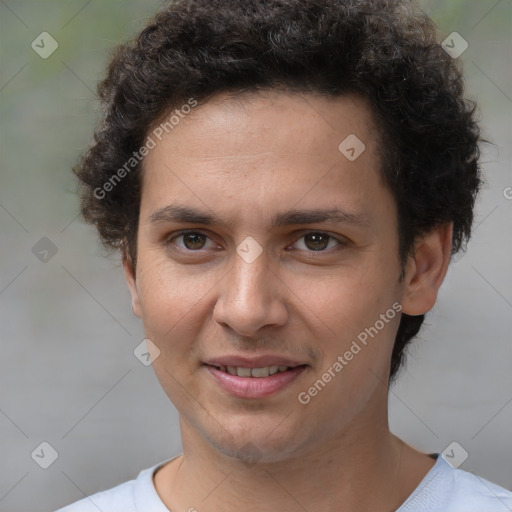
402, 223, 453, 316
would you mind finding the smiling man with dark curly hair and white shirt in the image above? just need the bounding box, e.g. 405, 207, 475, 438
57, 0, 512, 512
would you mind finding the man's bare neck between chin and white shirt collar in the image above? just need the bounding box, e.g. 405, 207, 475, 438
155, 402, 434, 512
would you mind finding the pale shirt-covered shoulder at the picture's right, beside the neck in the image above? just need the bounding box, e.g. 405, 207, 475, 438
397, 456, 512, 512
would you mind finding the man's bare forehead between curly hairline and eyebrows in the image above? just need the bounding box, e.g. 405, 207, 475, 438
141, 91, 386, 229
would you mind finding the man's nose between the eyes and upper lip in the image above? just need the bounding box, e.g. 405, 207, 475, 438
213, 248, 288, 336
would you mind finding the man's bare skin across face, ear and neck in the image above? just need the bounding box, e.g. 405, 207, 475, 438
123, 91, 451, 512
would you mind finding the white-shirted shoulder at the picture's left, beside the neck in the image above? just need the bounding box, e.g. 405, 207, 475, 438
56, 459, 172, 512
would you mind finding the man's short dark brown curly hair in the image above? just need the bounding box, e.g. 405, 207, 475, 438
73, 0, 482, 382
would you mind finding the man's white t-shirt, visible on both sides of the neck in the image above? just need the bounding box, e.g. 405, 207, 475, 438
56, 456, 512, 512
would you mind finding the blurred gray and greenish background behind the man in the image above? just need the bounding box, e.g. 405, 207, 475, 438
0, 0, 512, 512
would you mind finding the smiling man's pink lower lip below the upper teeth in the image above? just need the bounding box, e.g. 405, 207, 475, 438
205, 359, 307, 399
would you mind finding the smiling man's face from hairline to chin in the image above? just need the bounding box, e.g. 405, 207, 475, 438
125, 92, 412, 461
